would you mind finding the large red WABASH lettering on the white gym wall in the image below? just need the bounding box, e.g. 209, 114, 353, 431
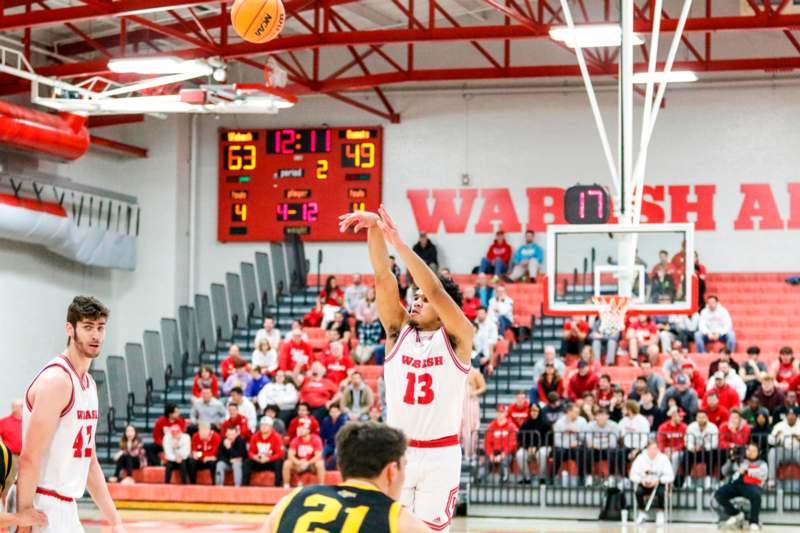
406, 183, 800, 233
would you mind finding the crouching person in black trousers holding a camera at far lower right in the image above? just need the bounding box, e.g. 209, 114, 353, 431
714, 444, 769, 531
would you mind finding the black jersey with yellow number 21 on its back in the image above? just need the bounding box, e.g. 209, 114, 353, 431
275, 481, 401, 533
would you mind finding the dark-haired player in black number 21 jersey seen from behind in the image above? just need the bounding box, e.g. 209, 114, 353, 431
261, 422, 431, 533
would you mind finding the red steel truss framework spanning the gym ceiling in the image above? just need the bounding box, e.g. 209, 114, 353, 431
0, 0, 800, 122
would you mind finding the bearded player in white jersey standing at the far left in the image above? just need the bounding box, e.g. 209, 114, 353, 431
17, 296, 125, 533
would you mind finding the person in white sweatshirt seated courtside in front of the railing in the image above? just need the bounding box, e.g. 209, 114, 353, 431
630, 441, 675, 525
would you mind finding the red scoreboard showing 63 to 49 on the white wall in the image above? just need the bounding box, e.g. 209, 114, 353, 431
217, 126, 383, 242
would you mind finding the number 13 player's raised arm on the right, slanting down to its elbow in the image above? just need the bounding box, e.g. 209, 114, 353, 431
376, 206, 475, 364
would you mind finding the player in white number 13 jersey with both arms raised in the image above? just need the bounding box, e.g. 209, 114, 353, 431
339, 206, 474, 532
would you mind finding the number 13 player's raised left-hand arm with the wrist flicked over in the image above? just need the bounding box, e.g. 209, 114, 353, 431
339, 211, 408, 336
